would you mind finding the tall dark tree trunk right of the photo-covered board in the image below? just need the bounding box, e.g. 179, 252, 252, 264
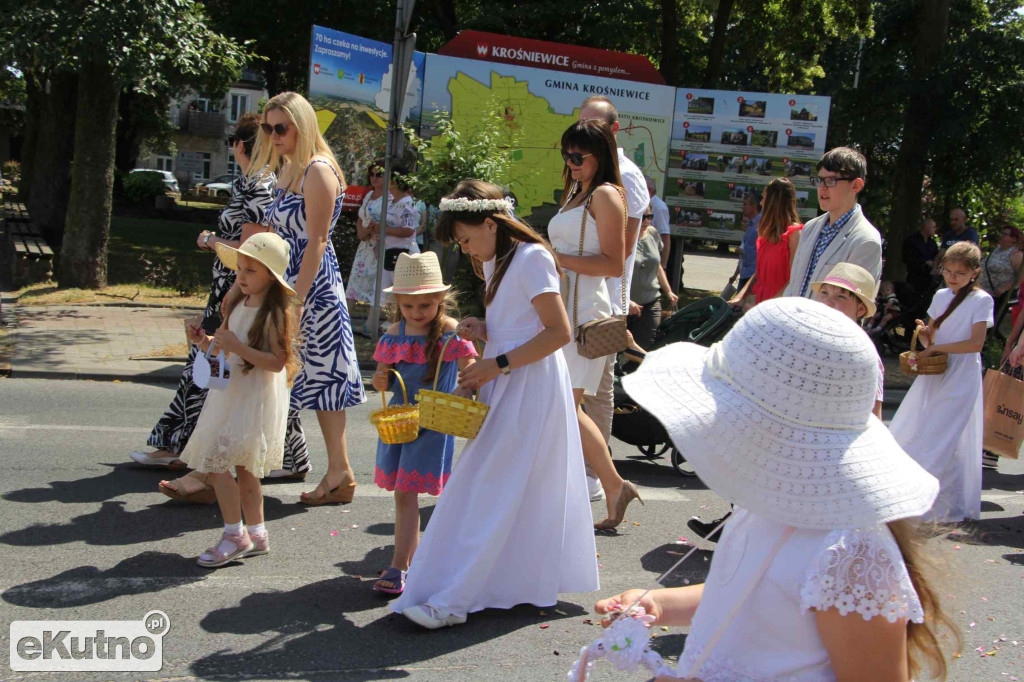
886, 0, 951, 281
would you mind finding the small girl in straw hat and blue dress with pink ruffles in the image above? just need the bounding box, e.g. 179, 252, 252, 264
374, 251, 476, 594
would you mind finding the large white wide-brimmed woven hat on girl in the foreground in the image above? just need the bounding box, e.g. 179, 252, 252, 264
623, 297, 939, 529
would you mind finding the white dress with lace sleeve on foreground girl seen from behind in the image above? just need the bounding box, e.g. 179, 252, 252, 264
662, 507, 925, 682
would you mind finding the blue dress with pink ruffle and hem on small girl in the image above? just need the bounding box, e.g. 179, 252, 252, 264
374, 321, 476, 495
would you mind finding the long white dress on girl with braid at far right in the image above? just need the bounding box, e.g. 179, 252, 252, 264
889, 289, 992, 523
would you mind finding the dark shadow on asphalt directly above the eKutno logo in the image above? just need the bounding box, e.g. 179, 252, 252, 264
0, 552, 210, 615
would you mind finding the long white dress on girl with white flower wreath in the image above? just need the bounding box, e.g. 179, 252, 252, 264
390, 244, 599, 615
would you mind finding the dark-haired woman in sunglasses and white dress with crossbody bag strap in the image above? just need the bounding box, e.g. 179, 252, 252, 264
548, 119, 642, 530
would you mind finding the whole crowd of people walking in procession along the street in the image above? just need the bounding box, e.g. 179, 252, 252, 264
117, 93, 1024, 682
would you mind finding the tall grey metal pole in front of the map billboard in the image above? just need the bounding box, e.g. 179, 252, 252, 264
369, 0, 416, 343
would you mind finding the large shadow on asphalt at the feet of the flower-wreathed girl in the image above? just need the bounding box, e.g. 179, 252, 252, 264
191, 569, 585, 680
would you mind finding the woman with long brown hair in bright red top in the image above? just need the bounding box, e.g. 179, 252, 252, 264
729, 177, 804, 305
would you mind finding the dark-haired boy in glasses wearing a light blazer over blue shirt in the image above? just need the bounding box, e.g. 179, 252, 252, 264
783, 146, 882, 298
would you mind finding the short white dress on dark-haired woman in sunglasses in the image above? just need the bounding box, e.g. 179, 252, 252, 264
548, 205, 622, 395
